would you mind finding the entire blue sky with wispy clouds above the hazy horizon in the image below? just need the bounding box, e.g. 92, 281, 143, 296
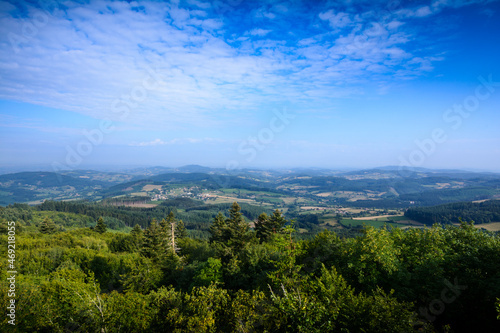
0, 0, 500, 171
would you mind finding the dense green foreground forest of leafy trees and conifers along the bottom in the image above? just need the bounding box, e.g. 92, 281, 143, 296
0, 203, 500, 332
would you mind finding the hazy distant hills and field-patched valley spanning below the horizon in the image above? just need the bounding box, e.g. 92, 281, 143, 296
0, 166, 500, 209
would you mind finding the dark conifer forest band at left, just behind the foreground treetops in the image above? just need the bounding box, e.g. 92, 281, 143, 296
0, 198, 326, 239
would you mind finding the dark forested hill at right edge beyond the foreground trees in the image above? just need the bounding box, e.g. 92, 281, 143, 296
405, 200, 500, 224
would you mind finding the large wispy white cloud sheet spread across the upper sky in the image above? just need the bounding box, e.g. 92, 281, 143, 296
0, 0, 496, 132
